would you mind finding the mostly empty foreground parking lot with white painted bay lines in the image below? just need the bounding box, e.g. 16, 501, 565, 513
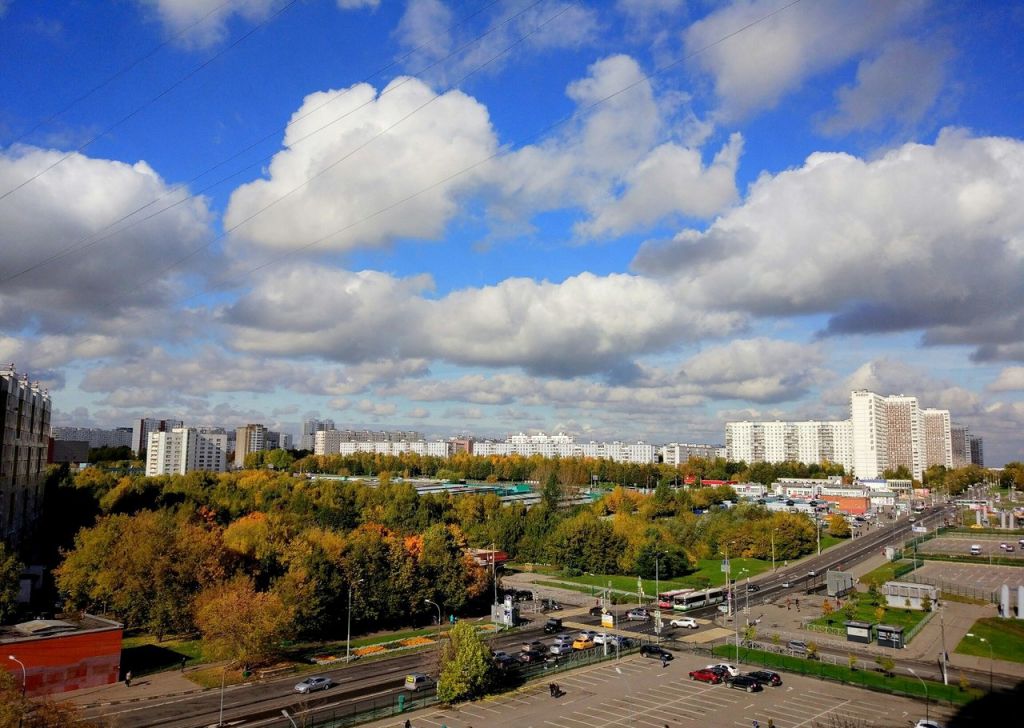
371, 653, 951, 728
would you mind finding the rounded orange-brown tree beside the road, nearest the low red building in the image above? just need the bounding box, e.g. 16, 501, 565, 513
196, 576, 293, 665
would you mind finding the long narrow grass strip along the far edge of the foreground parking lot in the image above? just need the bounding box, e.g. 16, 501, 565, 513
714, 645, 982, 704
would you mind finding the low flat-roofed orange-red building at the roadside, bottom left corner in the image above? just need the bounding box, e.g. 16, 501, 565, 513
0, 614, 122, 696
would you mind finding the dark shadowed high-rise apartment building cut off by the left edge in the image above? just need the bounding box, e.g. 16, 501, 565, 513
0, 365, 50, 544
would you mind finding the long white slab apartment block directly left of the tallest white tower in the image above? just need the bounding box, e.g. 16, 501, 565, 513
725, 420, 853, 471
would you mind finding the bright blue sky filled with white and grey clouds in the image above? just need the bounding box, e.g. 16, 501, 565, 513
0, 0, 1024, 465
